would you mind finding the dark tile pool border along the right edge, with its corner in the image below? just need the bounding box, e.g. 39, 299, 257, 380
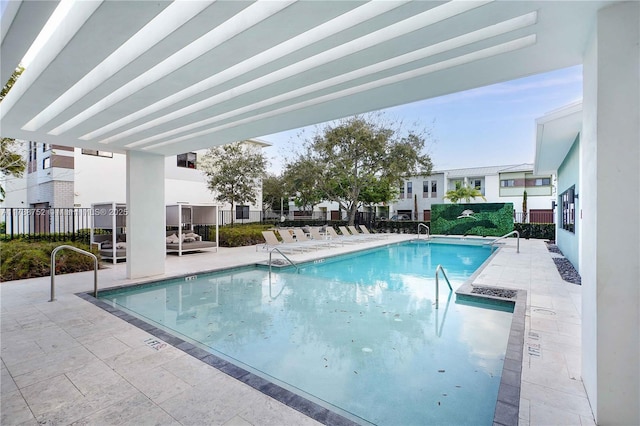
456, 281, 527, 426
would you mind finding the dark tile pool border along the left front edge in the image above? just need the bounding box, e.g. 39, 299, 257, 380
76, 292, 359, 426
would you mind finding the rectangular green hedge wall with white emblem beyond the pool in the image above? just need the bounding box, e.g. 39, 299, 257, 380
431, 203, 513, 237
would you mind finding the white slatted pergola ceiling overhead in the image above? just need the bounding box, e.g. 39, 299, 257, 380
0, 0, 611, 155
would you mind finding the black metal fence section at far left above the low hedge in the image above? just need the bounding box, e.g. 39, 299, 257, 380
0, 207, 92, 243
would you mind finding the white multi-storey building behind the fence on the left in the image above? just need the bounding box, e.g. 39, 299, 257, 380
2, 139, 269, 219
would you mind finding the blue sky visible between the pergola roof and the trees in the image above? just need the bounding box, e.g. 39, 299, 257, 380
260, 66, 582, 173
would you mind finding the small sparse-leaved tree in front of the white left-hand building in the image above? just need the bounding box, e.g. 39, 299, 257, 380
200, 142, 267, 224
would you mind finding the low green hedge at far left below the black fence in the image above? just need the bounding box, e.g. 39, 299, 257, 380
0, 240, 100, 281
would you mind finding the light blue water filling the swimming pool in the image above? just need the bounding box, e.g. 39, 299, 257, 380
100, 242, 512, 425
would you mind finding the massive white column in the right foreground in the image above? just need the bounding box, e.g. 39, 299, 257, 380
578, 1, 640, 425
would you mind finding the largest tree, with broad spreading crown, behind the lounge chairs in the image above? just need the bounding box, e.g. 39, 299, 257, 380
307, 114, 431, 225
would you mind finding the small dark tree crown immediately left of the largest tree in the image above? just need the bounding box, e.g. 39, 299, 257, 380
282, 153, 324, 211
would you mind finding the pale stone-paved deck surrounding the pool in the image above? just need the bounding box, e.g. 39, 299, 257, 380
0, 235, 594, 425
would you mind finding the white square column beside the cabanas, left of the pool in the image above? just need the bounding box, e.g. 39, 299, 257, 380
127, 151, 166, 278
